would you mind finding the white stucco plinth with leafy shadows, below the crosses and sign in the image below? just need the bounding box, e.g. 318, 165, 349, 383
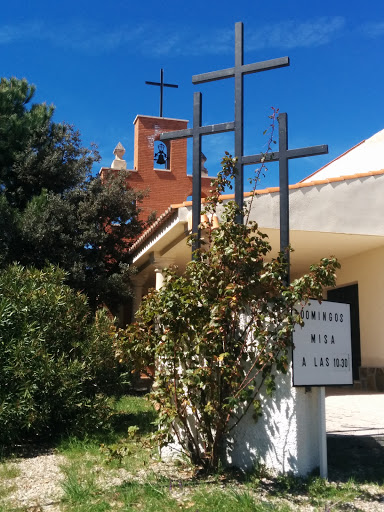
228, 373, 320, 475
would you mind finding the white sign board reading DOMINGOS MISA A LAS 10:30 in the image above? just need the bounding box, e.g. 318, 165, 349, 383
293, 300, 353, 386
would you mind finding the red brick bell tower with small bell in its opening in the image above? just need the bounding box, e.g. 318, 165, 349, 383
100, 116, 212, 219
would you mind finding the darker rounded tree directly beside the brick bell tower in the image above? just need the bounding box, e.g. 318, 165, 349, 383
19, 176, 147, 311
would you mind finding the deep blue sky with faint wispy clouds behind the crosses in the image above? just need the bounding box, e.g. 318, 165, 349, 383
0, 0, 384, 185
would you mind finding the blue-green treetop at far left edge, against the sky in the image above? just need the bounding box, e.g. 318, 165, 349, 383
0, 78, 93, 209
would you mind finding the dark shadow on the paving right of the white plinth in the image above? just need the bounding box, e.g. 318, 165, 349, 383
327, 435, 384, 485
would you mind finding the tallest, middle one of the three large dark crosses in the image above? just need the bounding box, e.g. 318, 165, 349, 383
192, 22, 289, 222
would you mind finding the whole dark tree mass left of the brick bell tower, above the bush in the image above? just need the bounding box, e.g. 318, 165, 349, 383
0, 78, 144, 311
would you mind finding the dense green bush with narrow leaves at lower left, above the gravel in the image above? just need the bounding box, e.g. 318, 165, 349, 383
0, 265, 124, 445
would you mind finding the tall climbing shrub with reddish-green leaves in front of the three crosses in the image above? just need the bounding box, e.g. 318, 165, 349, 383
119, 155, 339, 470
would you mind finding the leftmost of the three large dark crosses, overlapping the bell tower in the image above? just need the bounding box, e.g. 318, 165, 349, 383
160, 92, 235, 252
